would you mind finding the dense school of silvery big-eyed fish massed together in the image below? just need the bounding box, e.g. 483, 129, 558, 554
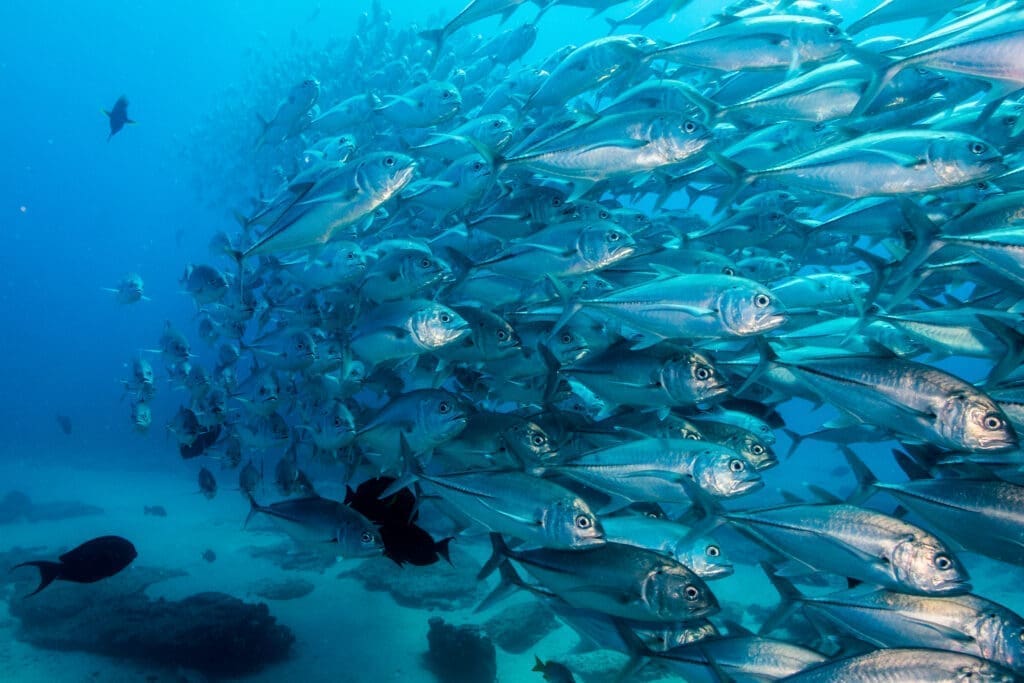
130, 0, 1024, 682
